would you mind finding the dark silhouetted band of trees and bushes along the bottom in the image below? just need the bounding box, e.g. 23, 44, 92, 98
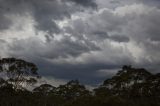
0, 58, 160, 106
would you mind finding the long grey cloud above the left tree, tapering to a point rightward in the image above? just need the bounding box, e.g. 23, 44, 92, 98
9, 36, 100, 59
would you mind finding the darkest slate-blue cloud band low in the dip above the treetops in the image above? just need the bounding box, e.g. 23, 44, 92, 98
41, 64, 121, 85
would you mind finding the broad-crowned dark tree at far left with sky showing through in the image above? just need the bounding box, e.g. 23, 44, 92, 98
0, 58, 40, 89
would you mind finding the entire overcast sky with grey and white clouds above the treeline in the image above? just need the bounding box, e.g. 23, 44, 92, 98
0, 0, 160, 86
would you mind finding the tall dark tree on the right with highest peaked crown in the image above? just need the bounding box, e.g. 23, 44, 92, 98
102, 65, 152, 97
